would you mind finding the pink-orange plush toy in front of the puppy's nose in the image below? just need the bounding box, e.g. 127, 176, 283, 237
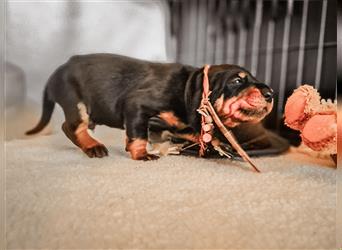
285, 85, 337, 155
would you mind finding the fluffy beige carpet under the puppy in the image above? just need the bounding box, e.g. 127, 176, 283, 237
6, 129, 336, 249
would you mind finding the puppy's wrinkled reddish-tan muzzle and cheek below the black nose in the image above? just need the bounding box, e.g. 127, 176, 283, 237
214, 88, 273, 127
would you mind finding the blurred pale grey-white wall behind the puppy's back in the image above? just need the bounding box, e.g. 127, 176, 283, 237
6, 1, 166, 103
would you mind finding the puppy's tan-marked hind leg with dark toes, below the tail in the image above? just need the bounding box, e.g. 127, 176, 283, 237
62, 102, 108, 158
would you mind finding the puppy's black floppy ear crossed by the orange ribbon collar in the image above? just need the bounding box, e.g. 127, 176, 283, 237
184, 67, 225, 131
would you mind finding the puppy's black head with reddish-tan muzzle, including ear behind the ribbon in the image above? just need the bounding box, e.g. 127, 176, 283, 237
185, 65, 273, 128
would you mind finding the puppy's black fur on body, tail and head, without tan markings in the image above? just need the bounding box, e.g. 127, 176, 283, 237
27, 54, 270, 158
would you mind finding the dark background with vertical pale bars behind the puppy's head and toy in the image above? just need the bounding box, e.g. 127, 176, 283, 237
168, 0, 337, 143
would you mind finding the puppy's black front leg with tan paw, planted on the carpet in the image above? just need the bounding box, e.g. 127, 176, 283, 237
125, 110, 159, 161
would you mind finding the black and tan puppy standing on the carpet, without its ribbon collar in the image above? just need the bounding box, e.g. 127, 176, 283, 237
27, 54, 273, 160
